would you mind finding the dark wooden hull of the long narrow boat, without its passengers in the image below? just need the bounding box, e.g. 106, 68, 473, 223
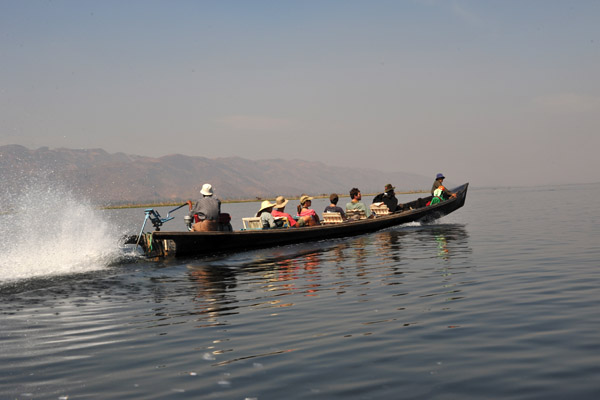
126, 183, 469, 257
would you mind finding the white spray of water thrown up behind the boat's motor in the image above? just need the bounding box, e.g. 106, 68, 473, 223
0, 184, 122, 283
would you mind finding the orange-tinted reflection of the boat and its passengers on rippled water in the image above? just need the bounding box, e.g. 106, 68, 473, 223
180, 225, 471, 324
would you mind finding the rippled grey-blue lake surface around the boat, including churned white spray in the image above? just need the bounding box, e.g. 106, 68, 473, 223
0, 184, 600, 400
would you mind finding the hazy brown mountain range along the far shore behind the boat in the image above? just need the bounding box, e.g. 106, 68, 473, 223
0, 145, 432, 205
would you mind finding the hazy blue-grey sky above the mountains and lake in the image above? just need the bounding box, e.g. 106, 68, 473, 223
0, 0, 600, 186
